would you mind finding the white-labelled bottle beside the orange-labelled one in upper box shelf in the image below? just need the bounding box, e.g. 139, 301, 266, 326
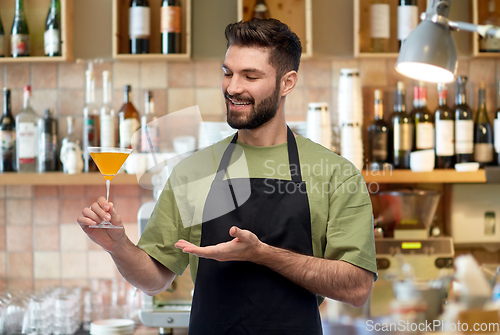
129, 0, 151, 54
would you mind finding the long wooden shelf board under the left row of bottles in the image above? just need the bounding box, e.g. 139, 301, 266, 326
0, 172, 151, 186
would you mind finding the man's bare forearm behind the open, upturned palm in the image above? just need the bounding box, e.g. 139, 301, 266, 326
253, 243, 373, 307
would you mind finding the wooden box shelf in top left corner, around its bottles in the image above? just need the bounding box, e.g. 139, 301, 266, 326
0, 0, 73, 63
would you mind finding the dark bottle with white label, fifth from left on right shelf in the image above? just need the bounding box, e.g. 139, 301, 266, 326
454, 76, 474, 163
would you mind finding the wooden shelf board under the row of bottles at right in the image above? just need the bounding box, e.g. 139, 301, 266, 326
362, 169, 486, 184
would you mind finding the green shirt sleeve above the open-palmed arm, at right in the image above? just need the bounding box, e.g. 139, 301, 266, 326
325, 173, 377, 279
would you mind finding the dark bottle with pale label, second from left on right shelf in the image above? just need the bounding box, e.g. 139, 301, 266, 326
391, 81, 413, 169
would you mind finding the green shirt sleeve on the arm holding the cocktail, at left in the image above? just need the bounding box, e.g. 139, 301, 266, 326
137, 180, 190, 276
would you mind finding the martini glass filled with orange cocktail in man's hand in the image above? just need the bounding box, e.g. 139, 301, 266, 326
88, 147, 132, 228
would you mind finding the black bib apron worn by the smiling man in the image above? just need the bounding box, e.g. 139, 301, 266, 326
189, 128, 322, 335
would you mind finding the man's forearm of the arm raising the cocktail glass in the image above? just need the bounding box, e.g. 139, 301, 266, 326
109, 238, 175, 295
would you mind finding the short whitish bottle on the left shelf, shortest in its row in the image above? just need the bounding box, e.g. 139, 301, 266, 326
60, 116, 83, 173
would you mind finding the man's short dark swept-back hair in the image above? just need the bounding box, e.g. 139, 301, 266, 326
225, 19, 302, 80
